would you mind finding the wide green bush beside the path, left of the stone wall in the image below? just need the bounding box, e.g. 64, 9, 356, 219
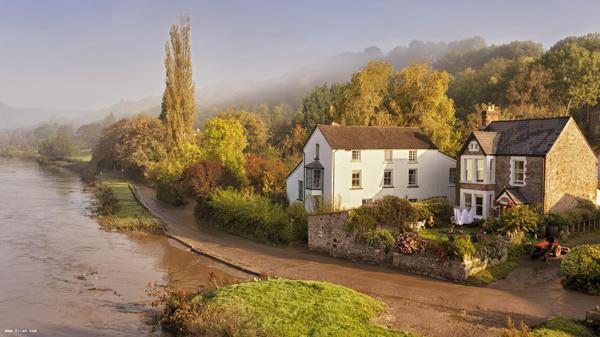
208, 189, 293, 243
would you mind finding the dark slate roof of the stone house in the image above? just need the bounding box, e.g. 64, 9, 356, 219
473, 117, 571, 156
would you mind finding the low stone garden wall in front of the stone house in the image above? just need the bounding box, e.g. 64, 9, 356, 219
392, 248, 508, 281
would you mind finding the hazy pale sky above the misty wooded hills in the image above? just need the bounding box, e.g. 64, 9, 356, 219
0, 0, 600, 109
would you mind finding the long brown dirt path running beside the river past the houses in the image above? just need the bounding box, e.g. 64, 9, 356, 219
136, 185, 600, 337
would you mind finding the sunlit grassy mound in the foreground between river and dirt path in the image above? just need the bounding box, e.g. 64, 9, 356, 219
162, 279, 416, 337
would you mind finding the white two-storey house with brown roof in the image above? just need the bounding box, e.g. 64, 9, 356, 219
286, 124, 456, 211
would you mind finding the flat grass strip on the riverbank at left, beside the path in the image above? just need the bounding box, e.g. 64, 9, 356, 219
96, 176, 164, 232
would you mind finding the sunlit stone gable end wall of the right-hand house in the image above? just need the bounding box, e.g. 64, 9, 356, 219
544, 119, 598, 212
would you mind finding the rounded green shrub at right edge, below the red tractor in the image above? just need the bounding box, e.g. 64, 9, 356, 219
560, 244, 600, 295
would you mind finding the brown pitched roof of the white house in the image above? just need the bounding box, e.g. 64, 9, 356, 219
317, 124, 437, 150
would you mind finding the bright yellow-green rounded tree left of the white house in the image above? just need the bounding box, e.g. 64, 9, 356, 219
201, 118, 248, 177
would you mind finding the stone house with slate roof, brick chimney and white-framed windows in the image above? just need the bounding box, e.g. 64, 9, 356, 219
458, 108, 598, 219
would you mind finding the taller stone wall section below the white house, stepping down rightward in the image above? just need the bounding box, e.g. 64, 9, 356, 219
308, 211, 386, 264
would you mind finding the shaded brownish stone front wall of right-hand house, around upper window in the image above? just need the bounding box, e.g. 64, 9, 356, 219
495, 156, 544, 207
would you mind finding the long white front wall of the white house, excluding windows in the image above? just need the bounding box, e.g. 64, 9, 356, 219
333, 149, 456, 208
